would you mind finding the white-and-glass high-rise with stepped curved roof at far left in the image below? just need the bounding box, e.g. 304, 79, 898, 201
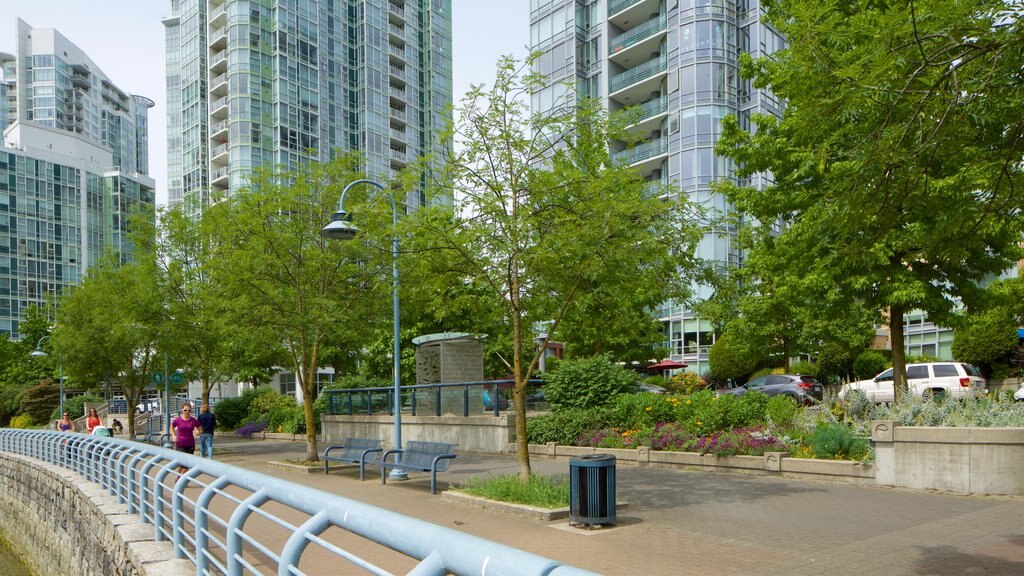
0, 19, 155, 338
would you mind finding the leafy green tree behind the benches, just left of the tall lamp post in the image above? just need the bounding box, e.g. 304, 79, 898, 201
206, 158, 372, 460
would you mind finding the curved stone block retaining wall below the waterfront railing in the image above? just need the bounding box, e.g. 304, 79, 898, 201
0, 453, 195, 576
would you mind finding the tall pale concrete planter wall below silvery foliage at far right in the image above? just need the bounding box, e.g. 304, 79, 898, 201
871, 421, 1024, 496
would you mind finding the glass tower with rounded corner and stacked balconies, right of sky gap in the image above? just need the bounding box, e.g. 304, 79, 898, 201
530, 0, 784, 373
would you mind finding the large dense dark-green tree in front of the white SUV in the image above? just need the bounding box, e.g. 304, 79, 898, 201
718, 0, 1024, 395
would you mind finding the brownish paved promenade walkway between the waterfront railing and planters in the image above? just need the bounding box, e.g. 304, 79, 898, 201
216, 438, 1024, 576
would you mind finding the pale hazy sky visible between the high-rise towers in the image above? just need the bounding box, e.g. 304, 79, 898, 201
0, 0, 529, 204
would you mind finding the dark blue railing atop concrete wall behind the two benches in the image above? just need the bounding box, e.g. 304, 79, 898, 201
321, 380, 543, 416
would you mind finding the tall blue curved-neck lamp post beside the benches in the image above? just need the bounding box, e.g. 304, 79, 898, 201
321, 178, 409, 480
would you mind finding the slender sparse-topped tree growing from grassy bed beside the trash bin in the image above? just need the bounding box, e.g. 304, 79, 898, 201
424, 56, 699, 480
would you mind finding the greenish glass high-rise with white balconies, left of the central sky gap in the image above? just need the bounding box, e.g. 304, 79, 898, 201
164, 0, 452, 209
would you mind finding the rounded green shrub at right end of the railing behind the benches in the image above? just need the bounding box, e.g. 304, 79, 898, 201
544, 356, 637, 412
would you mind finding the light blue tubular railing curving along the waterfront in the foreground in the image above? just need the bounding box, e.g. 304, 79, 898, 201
0, 429, 592, 576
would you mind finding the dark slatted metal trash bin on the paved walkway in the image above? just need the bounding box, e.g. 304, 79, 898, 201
569, 454, 615, 527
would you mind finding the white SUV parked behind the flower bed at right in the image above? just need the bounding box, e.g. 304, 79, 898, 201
839, 362, 988, 402
